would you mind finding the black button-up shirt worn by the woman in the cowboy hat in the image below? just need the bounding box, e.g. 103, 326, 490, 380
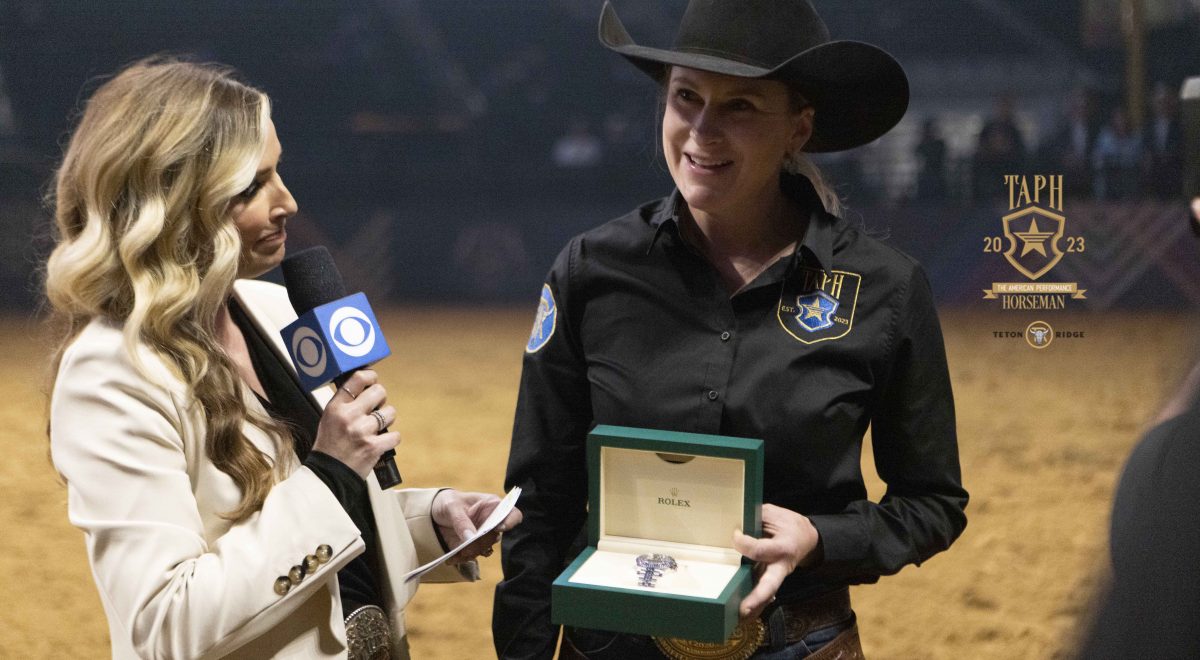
493, 175, 967, 658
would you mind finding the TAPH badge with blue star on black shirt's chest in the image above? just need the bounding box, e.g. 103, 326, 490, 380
776, 268, 863, 343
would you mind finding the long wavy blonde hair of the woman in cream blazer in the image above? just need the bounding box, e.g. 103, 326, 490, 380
46, 56, 289, 521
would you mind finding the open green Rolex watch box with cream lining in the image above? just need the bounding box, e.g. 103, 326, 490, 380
551, 426, 763, 643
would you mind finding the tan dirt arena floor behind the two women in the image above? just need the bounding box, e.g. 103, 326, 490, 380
0, 306, 1200, 660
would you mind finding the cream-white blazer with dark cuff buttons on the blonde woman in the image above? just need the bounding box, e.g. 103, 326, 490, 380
50, 280, 469, 660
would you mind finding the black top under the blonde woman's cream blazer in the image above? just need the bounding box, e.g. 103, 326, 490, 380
229, 299, 383, 616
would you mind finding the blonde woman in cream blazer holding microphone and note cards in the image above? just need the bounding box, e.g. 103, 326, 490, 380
46, 59, 520, 659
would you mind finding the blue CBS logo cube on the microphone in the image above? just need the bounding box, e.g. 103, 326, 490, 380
280, 293, 391, 390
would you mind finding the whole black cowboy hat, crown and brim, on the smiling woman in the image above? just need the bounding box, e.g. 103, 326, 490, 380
600, 0, 908, 151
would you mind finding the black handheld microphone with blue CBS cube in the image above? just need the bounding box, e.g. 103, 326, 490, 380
280, 246, 401, 488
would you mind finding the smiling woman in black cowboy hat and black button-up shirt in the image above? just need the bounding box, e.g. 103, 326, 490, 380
493, 0, 967, 659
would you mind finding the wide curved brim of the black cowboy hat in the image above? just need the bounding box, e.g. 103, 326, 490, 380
600, 2, 908, 152
